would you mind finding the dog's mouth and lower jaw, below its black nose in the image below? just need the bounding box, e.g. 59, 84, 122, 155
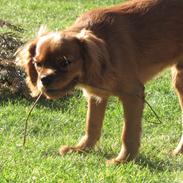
44, 78, 78, 99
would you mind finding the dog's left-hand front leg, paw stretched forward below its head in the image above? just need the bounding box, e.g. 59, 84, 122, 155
60, 97, 107, 155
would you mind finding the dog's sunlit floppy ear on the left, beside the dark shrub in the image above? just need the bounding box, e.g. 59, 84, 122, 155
16, 42, 39, 97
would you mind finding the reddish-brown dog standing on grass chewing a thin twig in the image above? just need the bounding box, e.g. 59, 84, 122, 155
18, 0, 183, 163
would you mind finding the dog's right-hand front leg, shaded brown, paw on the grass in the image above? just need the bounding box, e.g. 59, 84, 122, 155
107, 88, 144, 164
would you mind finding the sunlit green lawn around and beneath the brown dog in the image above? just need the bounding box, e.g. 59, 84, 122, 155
0, 0, 183, 183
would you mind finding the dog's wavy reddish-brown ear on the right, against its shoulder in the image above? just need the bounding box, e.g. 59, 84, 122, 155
77, 29, 109, 79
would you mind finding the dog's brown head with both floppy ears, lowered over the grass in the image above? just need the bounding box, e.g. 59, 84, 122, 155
17, 26, 107, 98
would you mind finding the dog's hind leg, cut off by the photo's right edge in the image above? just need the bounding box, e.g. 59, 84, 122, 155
172, 64, 183, 155
